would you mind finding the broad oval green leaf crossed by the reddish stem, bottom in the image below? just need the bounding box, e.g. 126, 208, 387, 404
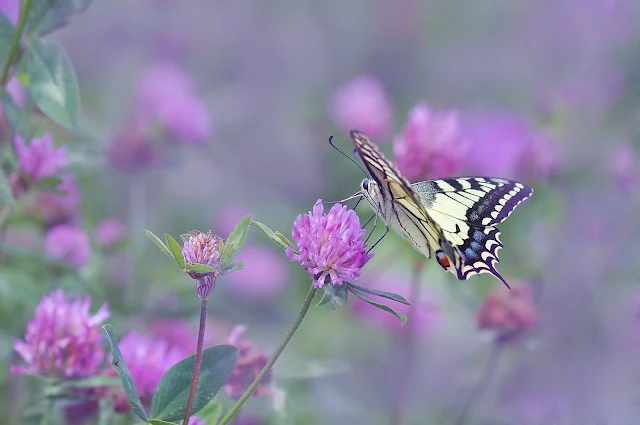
151, 345, 238, 421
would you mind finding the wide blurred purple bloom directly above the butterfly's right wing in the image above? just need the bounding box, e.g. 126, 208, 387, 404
465, 112, 558, 179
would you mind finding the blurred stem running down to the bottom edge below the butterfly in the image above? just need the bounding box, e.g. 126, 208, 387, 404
389, 259, 425, 425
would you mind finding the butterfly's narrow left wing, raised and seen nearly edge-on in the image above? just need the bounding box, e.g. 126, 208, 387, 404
351, 131, 442, 258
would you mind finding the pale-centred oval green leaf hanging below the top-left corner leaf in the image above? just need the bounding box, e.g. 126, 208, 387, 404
24, 38, 80, 129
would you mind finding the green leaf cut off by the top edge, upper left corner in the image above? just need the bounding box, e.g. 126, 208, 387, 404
27, 0, 92, 36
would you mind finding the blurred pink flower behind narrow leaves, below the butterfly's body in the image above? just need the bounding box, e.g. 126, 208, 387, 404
349, 272, 438, 335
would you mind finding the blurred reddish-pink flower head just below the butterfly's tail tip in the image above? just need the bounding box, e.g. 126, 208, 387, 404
477, 282, 538, 338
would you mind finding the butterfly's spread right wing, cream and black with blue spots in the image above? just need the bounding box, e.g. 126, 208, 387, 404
412, 177, 533, 286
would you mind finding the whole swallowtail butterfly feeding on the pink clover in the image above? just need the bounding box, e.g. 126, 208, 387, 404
350, 130, 533, 287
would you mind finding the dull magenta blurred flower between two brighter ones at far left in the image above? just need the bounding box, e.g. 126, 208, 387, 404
33, 173, 82, 228
